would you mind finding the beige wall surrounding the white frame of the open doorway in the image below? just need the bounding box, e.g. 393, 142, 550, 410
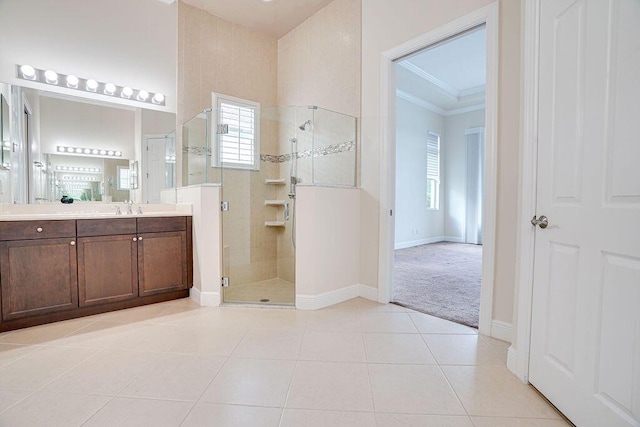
360, 0, 520, 322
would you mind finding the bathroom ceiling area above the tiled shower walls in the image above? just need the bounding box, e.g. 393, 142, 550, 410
181, 0, 332, 39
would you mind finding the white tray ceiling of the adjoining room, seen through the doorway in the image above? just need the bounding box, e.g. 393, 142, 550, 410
397, 27, 487, 112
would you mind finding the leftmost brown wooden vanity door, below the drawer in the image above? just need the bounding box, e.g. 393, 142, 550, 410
0, 238, 78, 321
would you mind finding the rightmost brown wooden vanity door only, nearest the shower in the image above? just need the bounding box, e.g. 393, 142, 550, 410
138, 231, 188, 296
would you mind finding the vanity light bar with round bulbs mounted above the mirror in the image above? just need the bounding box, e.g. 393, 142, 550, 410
17, 64, 165, 105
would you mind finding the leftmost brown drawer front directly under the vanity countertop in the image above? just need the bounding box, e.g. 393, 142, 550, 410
0, 220, 76, 240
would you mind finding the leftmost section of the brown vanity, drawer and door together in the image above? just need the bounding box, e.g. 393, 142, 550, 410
0, 220, 78, 321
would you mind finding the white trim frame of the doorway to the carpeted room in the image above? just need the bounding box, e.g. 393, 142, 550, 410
378, 3, 500, 339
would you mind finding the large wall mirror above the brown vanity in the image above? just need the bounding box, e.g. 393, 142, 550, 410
2, 86, 175, 203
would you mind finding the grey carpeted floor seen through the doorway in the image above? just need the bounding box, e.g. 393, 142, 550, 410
393, 242, 482, 328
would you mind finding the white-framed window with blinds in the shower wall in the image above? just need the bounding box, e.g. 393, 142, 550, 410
214, 94, 260, 170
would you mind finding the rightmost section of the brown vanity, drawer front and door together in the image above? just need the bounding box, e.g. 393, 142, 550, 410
138, 217, 191, 296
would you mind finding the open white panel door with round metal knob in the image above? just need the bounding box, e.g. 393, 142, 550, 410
529, 0, 640, 427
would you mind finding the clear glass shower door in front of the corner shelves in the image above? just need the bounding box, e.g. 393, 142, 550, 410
221, 107, 295, 305
